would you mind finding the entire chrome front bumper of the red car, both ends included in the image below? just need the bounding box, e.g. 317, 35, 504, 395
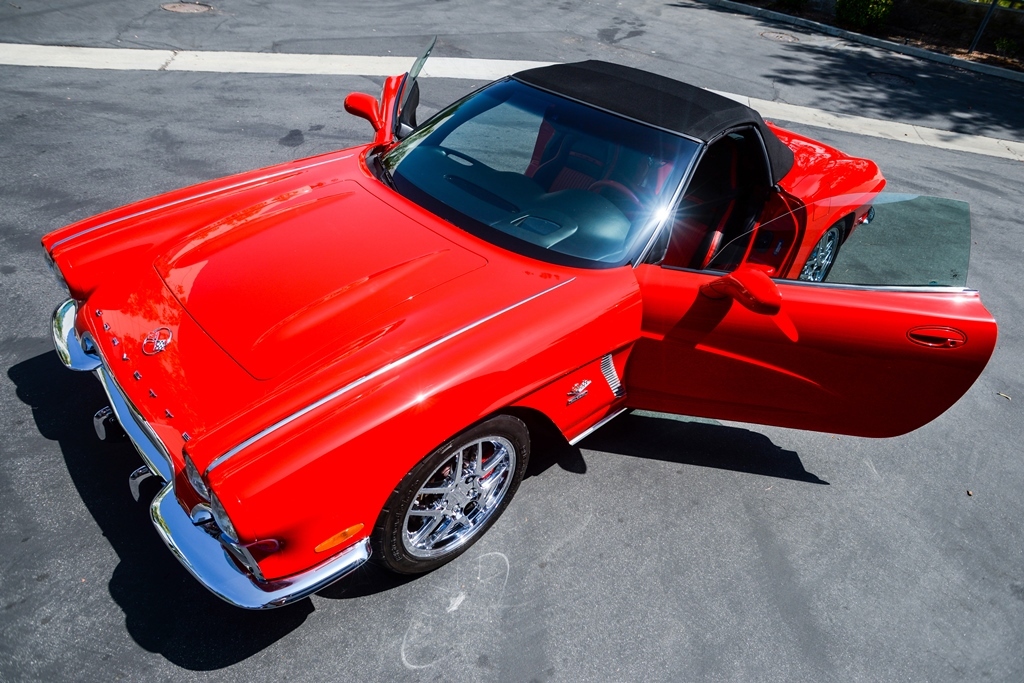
53, 299, 370, 609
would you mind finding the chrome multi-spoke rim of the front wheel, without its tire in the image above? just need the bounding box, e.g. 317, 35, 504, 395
401, 435, 516, 559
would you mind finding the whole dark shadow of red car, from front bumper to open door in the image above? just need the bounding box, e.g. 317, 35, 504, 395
7, 352, 827, 671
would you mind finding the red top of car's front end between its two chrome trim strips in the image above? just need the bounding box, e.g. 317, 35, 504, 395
51, 150, 588, 481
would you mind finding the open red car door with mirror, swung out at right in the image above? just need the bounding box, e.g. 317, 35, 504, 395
625, 196, 996, 436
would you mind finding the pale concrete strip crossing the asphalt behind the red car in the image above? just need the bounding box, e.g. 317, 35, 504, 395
0, 43, 1024, 161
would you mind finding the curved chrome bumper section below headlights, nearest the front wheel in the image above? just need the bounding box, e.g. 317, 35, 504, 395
150, 484, 370, 609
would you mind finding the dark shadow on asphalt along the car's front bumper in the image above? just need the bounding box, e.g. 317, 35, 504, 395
7, 352, 313, 671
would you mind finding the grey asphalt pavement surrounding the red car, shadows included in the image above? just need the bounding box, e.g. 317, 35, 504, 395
0, 0, 1024, 682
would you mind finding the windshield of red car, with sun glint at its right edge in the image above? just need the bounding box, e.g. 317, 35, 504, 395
383, 80, 698, 267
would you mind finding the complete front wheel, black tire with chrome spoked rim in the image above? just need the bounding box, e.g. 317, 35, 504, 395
371, 415, 529, 573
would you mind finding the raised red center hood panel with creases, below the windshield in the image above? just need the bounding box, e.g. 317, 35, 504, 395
156, 180, 486, 380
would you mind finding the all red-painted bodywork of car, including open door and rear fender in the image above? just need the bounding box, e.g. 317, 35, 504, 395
43, 70, 996, 593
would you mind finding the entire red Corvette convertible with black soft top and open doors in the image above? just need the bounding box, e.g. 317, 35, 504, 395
43, 56, 996, 608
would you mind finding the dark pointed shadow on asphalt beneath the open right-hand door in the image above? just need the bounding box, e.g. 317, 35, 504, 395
580, 413, 828, 485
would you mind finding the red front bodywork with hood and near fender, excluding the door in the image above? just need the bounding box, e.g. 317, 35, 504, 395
44, 150, 641, 579
